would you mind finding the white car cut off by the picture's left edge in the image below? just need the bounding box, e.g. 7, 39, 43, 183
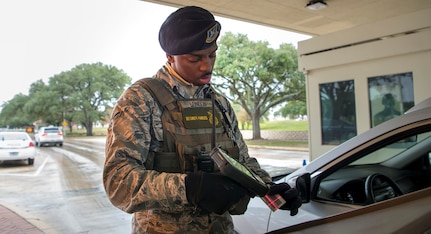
0, 132, 36, 165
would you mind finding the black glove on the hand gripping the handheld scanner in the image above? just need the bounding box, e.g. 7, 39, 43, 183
185, 172, 247, 215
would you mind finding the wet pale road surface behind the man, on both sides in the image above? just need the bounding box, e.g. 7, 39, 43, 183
0, 138, 308, 234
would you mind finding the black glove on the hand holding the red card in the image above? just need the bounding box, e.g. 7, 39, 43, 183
268, 183, 302, 216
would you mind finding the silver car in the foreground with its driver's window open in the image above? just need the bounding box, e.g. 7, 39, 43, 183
233, 98, 431, 234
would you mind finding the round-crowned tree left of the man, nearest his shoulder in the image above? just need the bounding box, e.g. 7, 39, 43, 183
61, 63, 131, 136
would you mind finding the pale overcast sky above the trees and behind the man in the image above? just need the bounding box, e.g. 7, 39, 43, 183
0, 0, 310, 105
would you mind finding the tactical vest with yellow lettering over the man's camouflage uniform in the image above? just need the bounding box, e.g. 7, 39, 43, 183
138, 78, 239, 173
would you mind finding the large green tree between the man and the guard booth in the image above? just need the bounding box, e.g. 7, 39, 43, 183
213, 32, 305, 139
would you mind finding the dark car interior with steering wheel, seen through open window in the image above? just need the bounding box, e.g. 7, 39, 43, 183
315, 123, 431, 206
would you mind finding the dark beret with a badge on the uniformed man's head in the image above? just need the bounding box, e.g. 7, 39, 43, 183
159, 6, 221, 55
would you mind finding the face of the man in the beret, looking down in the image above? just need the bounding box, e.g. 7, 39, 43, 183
167, 43, 218, 86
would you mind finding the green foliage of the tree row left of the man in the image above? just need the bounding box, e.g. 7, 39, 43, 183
0, 63, 131, 135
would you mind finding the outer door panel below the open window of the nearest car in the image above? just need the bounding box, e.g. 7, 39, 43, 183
269, 188, 431, 234
